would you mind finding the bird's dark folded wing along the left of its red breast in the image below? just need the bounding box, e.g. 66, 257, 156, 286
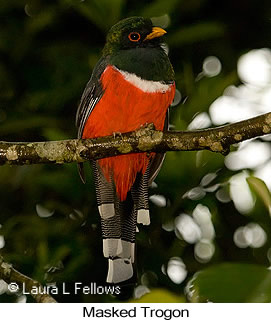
75, 57, 108, 183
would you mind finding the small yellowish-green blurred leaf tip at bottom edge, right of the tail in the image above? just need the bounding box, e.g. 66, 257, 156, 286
133, 288, 186, 303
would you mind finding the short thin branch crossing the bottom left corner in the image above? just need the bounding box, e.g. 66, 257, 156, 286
0, 256, 57, 303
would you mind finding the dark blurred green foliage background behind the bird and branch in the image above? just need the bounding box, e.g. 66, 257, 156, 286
0, 0, 271, 302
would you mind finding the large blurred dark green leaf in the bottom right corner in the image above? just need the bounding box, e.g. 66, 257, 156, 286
186, 263, 271, 303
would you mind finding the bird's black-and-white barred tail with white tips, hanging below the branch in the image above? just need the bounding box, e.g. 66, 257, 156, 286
93, 162, 150, 284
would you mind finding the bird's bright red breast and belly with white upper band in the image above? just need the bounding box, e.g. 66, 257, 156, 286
82, 65, 175, 201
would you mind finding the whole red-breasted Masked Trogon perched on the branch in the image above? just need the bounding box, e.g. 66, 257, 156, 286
76, 17, 176, 284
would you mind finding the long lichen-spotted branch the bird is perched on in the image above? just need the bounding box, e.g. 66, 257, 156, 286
0, 113, 271, 165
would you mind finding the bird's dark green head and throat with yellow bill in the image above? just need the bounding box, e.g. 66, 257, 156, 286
103, 17, 174, 82
